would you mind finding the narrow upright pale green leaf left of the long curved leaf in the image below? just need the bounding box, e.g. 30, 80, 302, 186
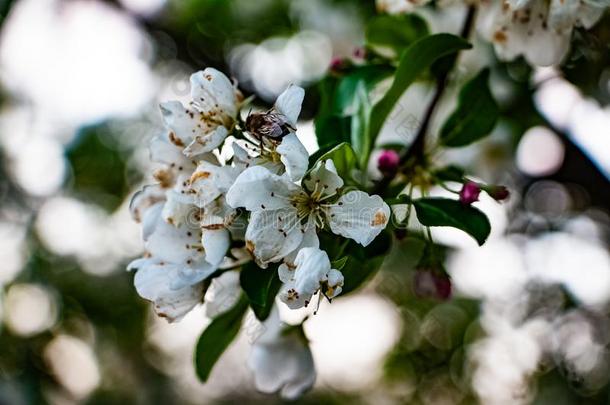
352, 82, 371, 167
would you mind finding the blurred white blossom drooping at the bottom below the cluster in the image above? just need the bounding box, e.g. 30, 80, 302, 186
248, 308, 316, 400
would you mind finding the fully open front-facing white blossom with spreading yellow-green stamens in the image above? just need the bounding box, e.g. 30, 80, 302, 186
226, 160, 390, 267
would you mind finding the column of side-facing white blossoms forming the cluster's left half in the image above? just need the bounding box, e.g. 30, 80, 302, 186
128, 69, 243, 321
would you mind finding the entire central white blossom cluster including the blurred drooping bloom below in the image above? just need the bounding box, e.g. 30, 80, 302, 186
128, 68, 390, 397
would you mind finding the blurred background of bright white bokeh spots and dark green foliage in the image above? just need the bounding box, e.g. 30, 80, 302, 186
0, 0, 610, 405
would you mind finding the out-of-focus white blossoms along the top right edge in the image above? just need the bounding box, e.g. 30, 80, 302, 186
377, 0, 610, 66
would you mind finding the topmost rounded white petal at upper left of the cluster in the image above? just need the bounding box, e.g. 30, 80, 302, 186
190, 68, 237, 118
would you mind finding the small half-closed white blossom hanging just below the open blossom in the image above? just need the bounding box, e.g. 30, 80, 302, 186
278, 247, 343, 309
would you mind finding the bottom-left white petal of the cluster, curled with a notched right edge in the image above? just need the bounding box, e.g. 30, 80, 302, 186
130, 259, 204, 322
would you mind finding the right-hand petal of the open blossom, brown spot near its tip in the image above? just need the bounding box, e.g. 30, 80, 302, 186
327, 191, 390, 246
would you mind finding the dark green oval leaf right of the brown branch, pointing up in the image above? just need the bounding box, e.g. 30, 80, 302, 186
440, 69, 500, 147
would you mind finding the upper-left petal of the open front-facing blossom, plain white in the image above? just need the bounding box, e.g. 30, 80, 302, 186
226, 166, 302, 211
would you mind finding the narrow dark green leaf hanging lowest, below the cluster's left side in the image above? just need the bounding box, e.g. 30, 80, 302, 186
195, 295, 248, 382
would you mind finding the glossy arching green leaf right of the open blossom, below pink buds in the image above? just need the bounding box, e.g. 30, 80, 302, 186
413, 197, 491, 245
